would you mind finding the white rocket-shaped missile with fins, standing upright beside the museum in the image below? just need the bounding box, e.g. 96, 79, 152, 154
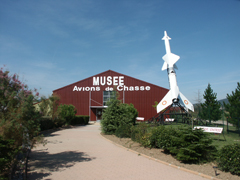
157, 31, 194, 113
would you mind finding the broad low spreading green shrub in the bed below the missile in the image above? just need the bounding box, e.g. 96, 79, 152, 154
150, 126, 217, 163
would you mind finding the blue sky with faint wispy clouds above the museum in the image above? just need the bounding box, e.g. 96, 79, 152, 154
0, 0, 240, 103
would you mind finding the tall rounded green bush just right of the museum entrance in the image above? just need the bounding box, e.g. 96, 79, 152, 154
101, 99, 138, 134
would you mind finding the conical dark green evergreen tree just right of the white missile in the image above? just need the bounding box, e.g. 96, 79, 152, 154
199, 84, 221, 124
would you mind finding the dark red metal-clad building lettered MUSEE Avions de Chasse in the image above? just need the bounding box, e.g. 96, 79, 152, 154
53, 70, 169, 121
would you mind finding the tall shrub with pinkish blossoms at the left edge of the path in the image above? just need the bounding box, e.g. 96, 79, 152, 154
0, 68, 41, 149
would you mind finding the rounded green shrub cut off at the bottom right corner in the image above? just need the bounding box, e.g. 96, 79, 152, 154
217, 144, 240, 176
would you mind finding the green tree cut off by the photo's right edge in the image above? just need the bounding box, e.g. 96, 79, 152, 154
223, 82, 240, 126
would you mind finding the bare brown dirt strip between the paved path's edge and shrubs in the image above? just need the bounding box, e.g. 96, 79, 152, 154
101, 134, 240, 180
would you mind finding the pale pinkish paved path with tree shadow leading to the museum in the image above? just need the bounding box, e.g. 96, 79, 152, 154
28, 125, 209, 180
